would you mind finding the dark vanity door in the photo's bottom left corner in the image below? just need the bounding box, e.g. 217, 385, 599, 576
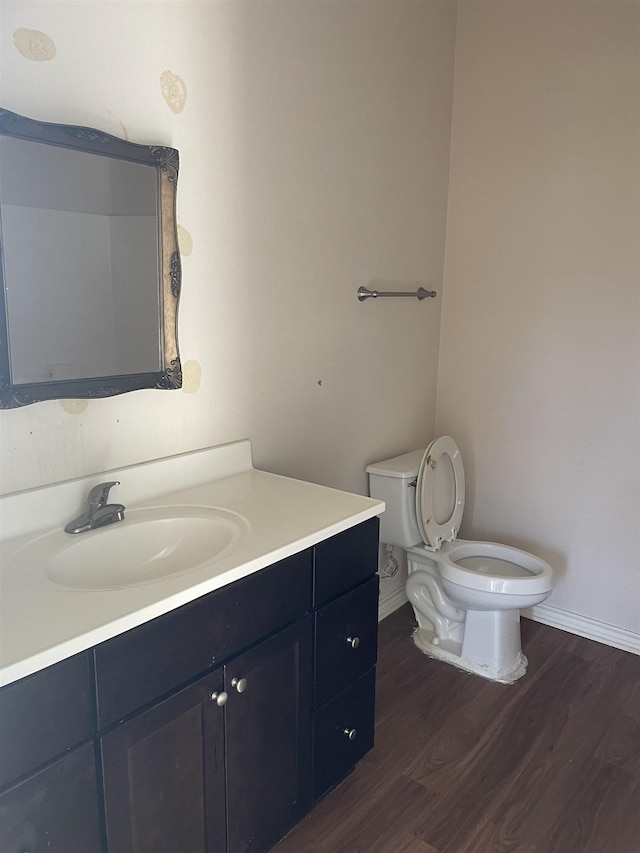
0, 743, 102, 853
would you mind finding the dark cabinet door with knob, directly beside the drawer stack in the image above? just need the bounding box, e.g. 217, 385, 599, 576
225, 616, 312, 853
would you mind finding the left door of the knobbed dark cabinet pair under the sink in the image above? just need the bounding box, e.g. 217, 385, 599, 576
101, 669, 226, 853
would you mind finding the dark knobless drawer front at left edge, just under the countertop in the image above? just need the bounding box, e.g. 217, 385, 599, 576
0, 652, 93, 787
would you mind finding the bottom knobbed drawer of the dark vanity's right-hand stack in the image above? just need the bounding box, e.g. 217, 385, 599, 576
313, 669, 376, 800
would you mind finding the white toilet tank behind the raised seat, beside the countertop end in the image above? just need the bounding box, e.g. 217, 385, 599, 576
367, 450, 424, 548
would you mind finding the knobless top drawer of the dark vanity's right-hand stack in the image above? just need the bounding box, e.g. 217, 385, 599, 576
313, 517, 380, 607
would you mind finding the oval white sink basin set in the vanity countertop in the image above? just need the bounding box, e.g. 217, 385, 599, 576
21, 506, 248, 590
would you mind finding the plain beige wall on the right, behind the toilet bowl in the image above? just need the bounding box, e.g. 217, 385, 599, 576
437, 0, 640, 632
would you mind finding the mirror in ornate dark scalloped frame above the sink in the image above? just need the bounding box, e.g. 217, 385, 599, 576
0, 109, 182, 408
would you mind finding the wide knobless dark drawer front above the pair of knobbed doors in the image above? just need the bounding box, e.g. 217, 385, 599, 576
94, 550, 311, 728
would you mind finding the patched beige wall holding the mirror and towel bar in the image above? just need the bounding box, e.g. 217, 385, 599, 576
0, 0, 455, 500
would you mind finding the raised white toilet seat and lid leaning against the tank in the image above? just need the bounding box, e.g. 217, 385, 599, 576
416, 435, 464, 549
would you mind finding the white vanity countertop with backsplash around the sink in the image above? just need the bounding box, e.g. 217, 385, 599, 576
0, 441, 384, 686
